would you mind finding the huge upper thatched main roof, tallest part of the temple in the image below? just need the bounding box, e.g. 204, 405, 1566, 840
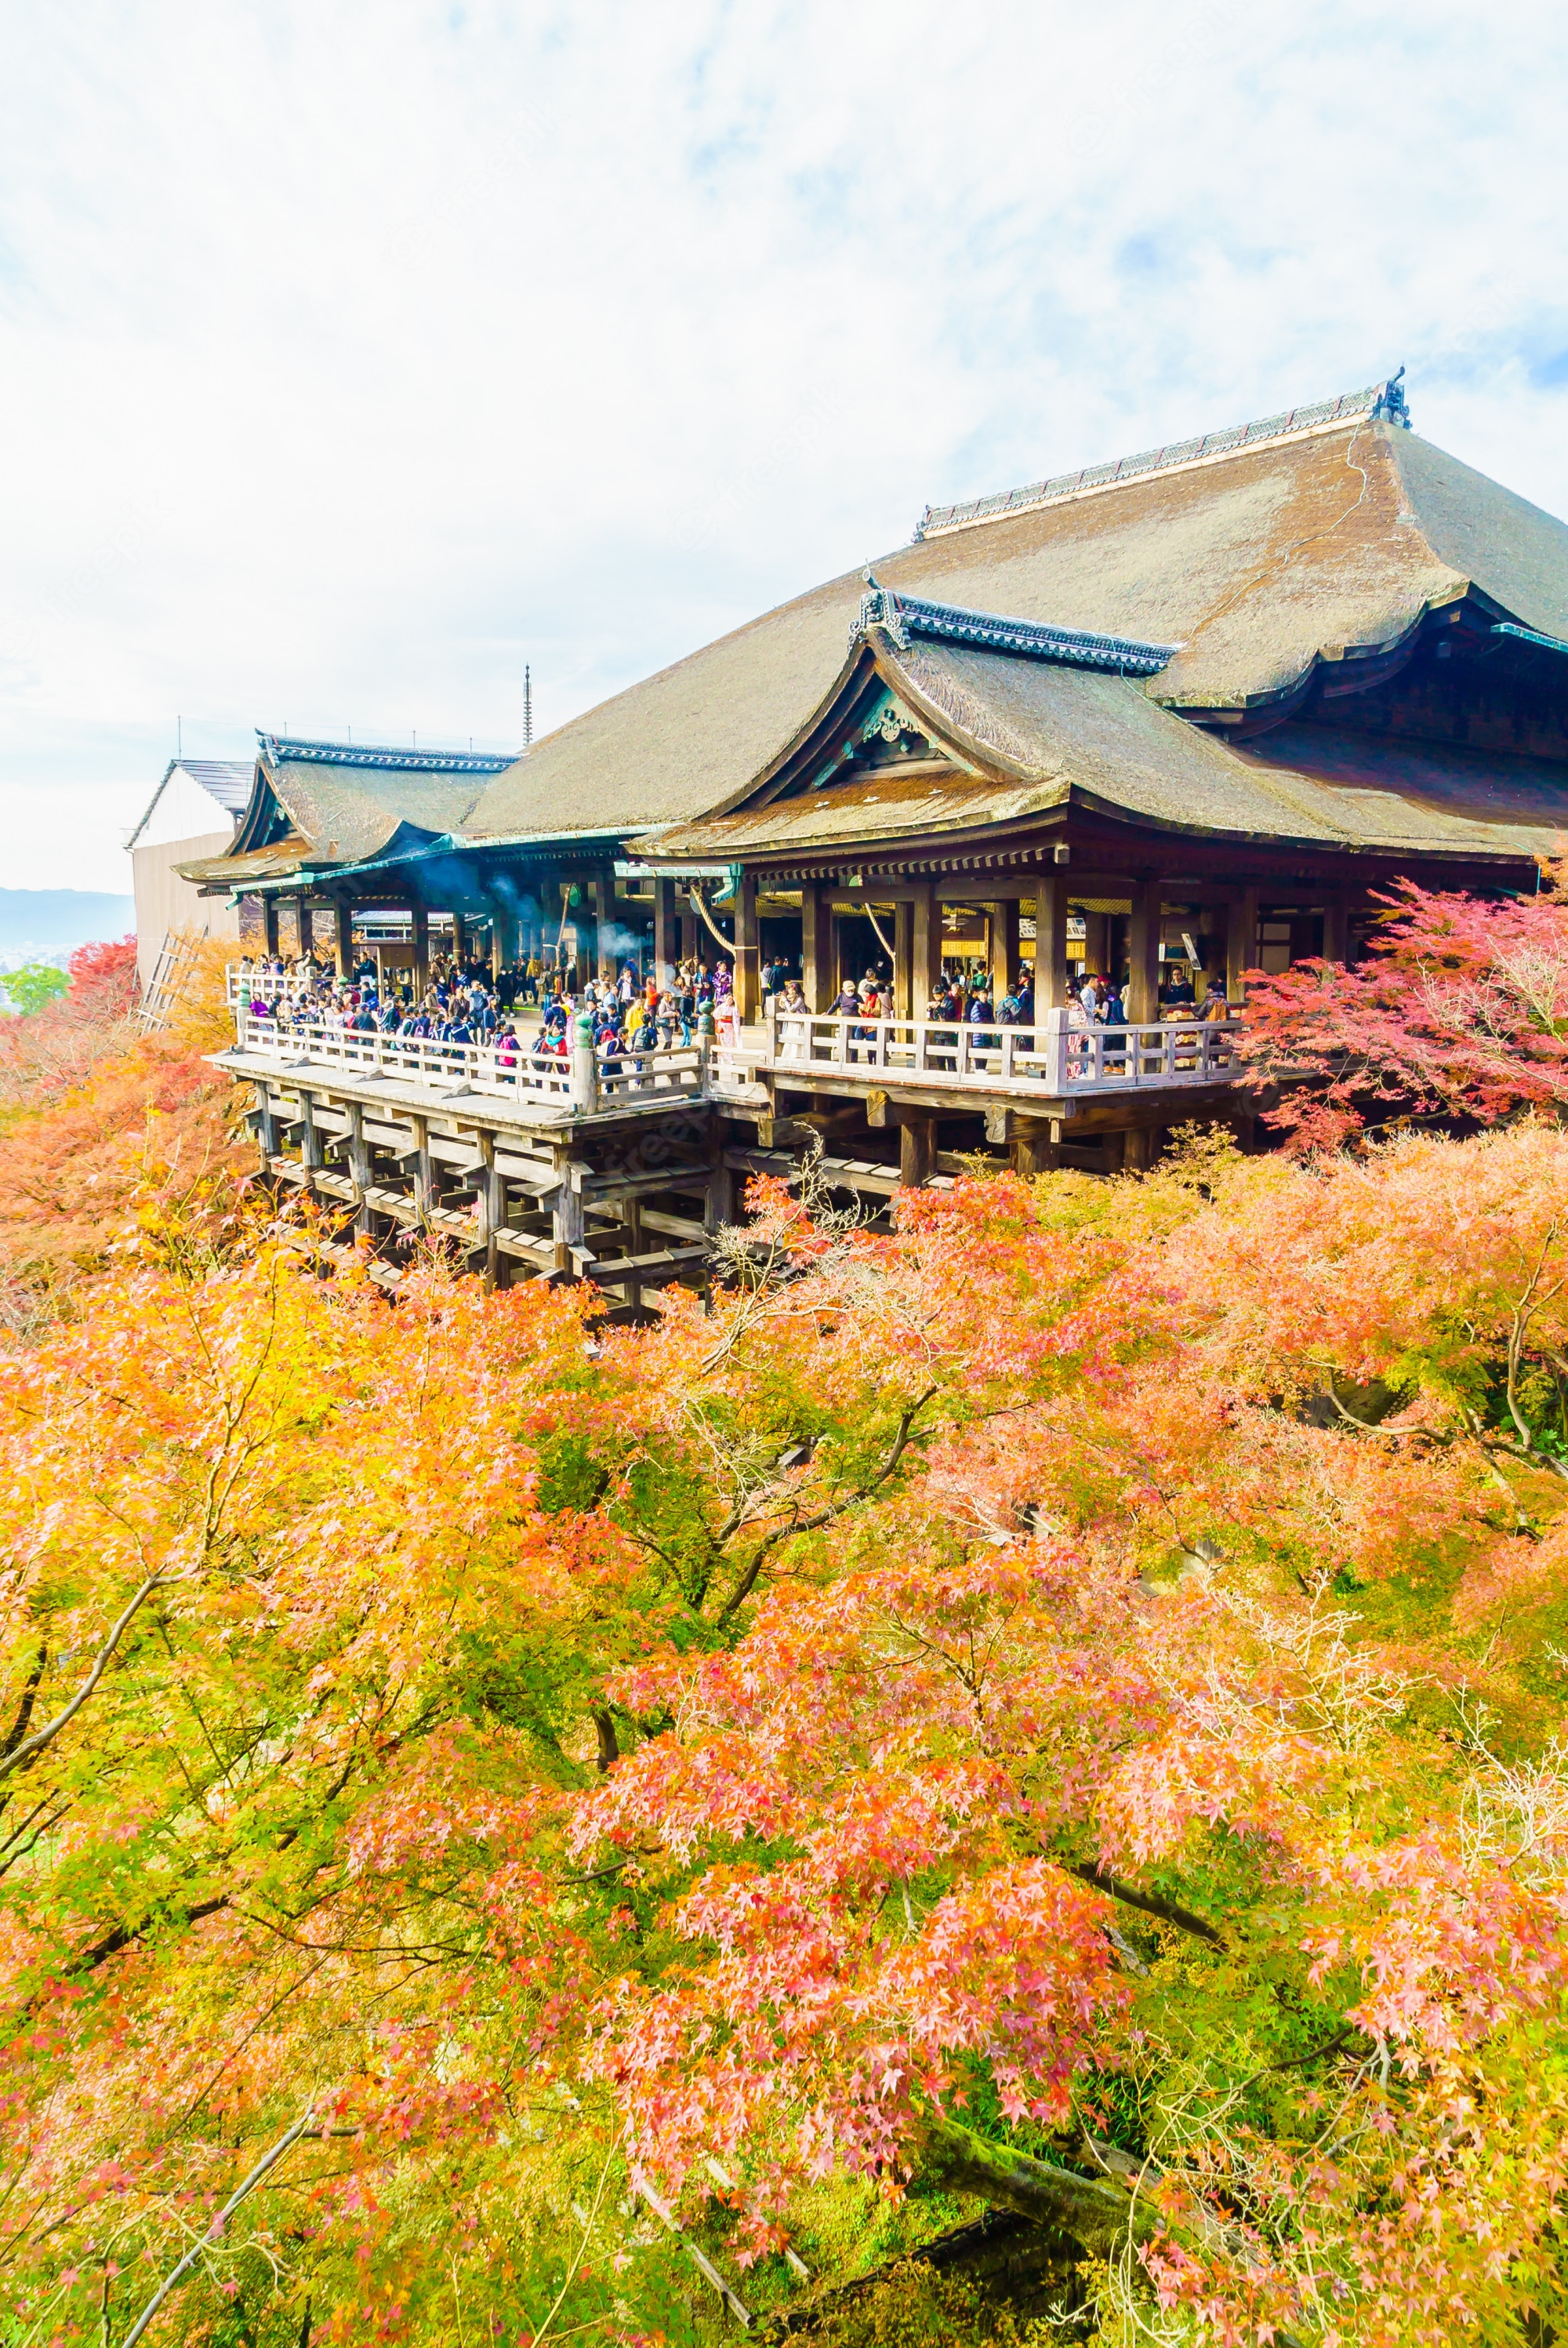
463, 390, 1568, 841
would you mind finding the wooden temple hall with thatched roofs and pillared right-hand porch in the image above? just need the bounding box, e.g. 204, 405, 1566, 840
186, 380, 1568, 1296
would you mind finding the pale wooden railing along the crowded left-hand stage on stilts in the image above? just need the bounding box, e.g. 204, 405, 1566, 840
234, 1007, 706, 1115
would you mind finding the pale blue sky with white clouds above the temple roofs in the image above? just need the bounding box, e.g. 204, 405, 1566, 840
0, 0, 1568, 890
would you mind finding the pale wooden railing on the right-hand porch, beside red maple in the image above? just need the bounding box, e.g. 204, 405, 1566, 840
753, 1005, 1242, 1096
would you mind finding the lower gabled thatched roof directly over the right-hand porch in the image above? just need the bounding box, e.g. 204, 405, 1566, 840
638, 620, 1568, 862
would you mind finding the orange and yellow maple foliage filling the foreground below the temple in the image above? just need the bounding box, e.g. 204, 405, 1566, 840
0, 948, 1568, 2348
